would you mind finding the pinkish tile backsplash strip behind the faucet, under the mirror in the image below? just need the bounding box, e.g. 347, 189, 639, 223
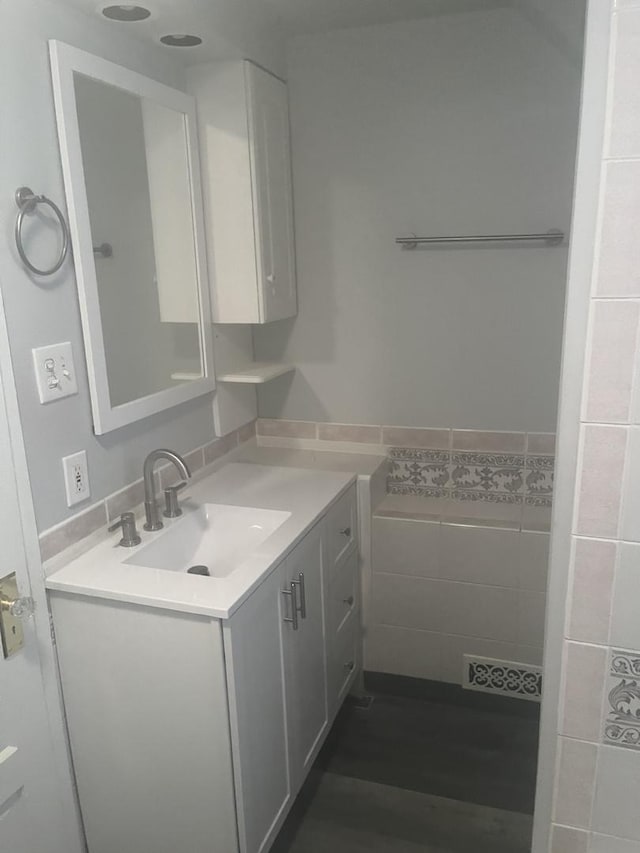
39, 422, 255, 562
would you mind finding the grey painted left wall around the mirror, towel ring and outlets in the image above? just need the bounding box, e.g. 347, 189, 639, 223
0, 0, 282, 530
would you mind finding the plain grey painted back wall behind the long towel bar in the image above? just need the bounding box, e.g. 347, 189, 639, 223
254, 4, 581, 431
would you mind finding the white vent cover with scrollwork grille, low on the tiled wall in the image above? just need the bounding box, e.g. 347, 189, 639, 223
462, 655, 542, 702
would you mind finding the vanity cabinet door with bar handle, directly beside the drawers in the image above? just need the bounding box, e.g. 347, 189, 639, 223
282, 524, 329, 791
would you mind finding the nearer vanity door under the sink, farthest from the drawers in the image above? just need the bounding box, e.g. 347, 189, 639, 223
225, 564, 291, 853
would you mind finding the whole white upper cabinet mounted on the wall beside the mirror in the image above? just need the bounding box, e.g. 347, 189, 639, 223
188, 61, 297, 323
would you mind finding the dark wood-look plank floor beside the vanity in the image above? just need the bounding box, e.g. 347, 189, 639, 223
272, 676, 538, 853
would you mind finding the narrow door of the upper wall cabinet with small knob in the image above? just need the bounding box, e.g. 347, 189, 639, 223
246, 63, 296, 323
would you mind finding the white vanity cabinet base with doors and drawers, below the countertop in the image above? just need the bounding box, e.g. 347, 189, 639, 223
50, 485, 360, 853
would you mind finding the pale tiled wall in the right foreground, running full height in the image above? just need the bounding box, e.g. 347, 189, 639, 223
551, 0, 640, 853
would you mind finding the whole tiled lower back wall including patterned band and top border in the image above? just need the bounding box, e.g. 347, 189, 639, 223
257, 419, 555, 684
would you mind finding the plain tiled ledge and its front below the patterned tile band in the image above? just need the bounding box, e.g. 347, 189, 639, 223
365, 512, 549, 684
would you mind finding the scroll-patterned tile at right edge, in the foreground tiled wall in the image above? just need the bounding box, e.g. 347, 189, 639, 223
603, 649, 640, 750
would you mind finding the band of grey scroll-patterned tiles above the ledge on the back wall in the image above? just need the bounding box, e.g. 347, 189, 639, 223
387, 447, 555, 507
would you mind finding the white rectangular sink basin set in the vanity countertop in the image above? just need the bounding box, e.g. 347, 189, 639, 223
124, 504, 291, 578
